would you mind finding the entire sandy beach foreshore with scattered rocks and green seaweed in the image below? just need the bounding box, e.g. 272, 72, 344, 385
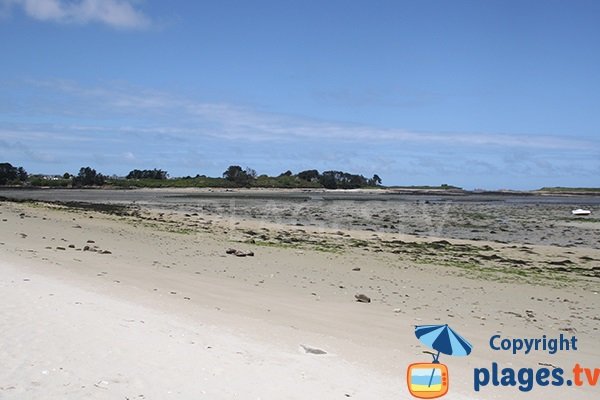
0, 191, 600, 400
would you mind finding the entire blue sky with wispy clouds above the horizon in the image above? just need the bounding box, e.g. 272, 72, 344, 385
0, 0, 600, 189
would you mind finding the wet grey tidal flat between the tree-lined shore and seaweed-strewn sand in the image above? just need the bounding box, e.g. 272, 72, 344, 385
0, 189, 600, 248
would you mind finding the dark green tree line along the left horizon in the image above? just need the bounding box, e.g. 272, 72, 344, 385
0, 163, 382, 189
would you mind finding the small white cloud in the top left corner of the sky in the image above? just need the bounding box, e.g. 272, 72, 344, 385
0, 0, 152, 29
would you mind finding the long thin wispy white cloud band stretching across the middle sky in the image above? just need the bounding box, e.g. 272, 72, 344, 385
12, 80, 600, 150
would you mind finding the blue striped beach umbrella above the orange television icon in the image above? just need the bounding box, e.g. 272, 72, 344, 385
415, 324, 473, 363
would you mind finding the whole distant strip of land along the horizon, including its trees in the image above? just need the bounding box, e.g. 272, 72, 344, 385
0, 162, 600, 196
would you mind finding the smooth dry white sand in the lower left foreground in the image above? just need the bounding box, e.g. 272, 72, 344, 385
0, 262, 404, 399
